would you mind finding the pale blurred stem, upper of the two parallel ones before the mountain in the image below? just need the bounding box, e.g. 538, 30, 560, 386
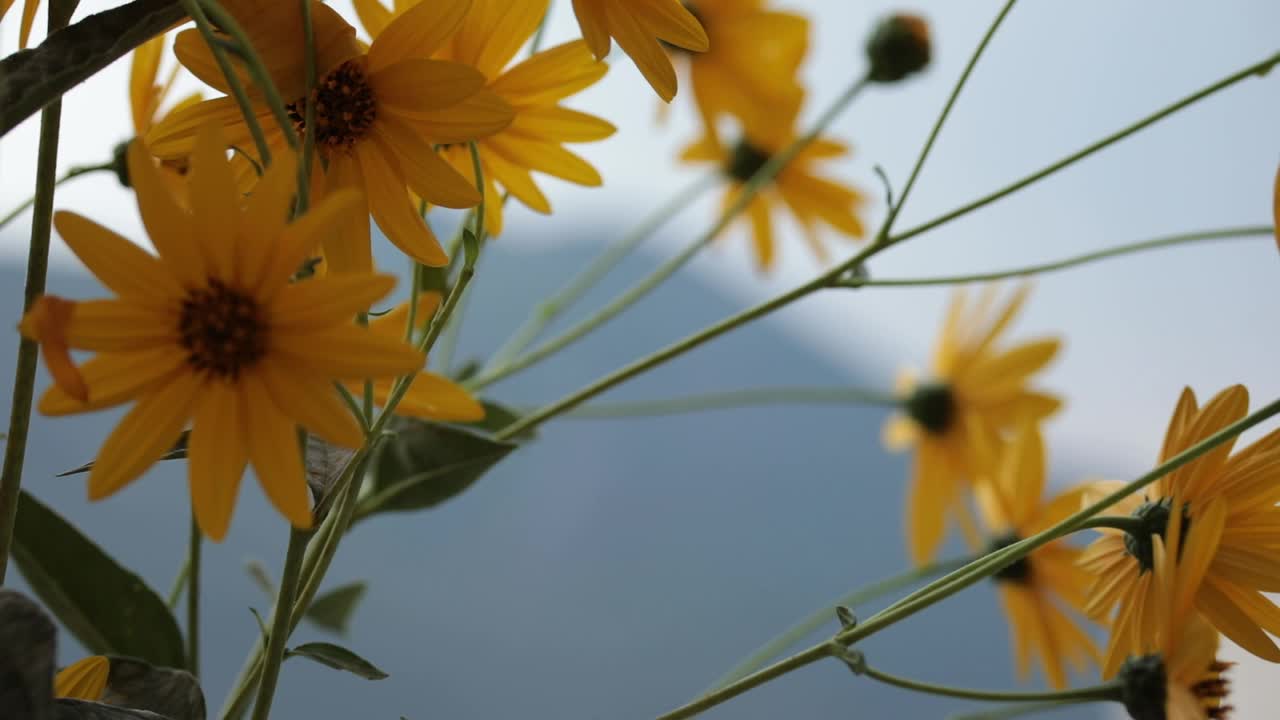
489, 172, 719, 371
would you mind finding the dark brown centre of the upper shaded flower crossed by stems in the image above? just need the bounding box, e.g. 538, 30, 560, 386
287, 60, 378, 149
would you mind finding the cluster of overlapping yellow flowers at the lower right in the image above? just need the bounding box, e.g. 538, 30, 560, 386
884, 286, 1280, 720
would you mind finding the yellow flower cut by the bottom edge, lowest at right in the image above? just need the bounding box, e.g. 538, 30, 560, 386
1103, 497, 1231, 720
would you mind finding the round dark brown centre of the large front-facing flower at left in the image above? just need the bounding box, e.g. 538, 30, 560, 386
178, 281, 266, 380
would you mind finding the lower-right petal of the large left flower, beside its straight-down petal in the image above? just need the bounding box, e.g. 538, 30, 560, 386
242, 373, 311, 529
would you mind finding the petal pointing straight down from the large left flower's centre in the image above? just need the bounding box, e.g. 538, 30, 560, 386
187, 380, 248, 542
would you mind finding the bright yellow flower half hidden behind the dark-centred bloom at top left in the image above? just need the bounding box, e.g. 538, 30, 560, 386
356, 0, 614, 236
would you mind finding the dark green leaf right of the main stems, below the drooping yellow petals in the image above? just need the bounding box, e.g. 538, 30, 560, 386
356, 418, 516, 519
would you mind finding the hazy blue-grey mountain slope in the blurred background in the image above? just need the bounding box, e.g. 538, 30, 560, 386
0, 231, 1094, 720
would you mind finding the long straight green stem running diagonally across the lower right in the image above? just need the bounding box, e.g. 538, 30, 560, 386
660, 400, 1280, 720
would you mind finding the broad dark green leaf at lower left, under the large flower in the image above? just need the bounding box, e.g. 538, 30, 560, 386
13, 492, 186, 667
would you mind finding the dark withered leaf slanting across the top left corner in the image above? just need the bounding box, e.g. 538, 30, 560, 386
0, 0, 186, 137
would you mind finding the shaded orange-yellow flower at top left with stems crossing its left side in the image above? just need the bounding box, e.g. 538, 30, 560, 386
147, 0, 512, 273
